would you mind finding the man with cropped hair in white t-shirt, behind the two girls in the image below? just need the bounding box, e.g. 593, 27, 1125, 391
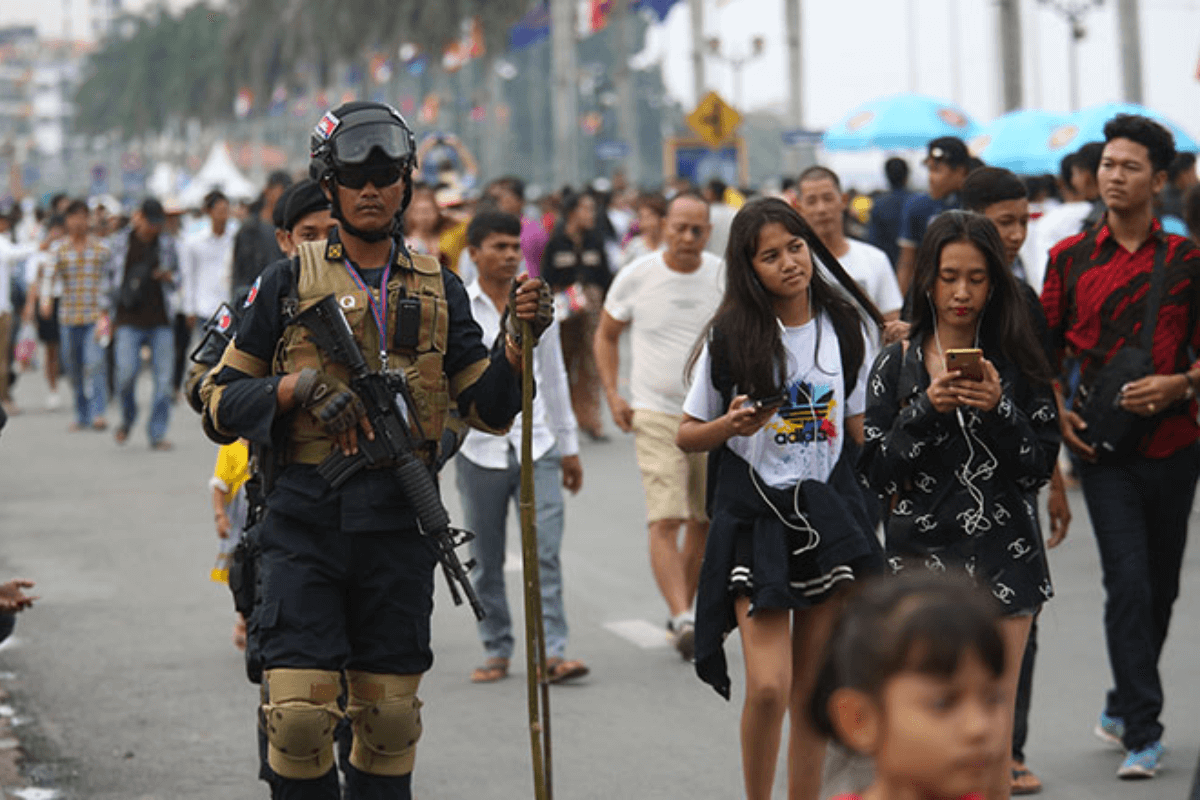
797, 167, 904, 323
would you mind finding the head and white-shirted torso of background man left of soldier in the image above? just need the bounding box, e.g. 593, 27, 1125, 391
179, 191, 236, 335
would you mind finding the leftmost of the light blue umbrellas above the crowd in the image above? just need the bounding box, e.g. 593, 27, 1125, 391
821, 94, 979, 150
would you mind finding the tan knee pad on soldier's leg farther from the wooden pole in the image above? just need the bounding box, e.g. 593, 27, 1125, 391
263, 669, 342, 781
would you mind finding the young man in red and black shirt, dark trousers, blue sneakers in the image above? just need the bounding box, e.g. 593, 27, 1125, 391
1042, 114, 1200, 778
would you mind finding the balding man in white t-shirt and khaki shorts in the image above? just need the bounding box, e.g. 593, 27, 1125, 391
595, 193, 725, 661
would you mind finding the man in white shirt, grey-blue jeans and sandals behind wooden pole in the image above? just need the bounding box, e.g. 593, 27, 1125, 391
455, 210, 588, 684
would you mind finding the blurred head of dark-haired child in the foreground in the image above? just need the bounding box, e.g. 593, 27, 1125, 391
810, 575, 1012, 798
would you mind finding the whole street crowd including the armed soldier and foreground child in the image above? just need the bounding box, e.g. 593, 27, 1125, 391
0, 103, 1200, 800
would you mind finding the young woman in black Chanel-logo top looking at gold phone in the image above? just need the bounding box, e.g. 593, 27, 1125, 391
859, 211, 1060, 800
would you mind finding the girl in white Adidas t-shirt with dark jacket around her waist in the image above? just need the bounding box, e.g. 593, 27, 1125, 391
677, 199, 882, 800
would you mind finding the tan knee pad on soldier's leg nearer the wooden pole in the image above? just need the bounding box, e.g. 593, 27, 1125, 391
346, 670, 421, 775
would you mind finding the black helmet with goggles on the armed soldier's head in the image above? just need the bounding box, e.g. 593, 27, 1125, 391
308, 101, 416, 240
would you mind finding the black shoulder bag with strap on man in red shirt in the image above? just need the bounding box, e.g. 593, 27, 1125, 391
1080, 242, 1166, 461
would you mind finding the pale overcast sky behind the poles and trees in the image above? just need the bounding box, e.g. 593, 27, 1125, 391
0, 0, 1200, 138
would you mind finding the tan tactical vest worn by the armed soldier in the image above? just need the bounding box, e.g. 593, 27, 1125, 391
272, 240, 450, 464
